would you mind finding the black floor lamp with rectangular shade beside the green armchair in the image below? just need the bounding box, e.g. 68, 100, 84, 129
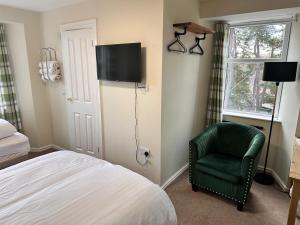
254, 62, 298, 185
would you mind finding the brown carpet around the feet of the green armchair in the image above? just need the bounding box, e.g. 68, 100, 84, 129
166, 172, 300, 225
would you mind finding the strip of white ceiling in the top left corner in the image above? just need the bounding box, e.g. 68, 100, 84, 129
0, 0, 86, 12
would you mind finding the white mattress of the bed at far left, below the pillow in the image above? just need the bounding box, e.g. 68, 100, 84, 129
0, 132, 30, 159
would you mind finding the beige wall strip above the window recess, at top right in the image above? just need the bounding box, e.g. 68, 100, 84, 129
199, 0, 300, 18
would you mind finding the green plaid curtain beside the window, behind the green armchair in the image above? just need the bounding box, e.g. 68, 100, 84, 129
206, 23, 228, 127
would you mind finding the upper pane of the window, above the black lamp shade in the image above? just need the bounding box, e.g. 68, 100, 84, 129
229, 23, 286, 59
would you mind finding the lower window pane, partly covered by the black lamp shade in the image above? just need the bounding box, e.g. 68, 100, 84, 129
224, 63, 276, 115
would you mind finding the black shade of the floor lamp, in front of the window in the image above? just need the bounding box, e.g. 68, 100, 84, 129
263, 62, 298, 82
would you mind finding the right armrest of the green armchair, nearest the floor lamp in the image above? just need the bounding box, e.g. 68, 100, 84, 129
241, 133, 265, 178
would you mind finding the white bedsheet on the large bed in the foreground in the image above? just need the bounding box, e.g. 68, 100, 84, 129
0, 151, 176, 225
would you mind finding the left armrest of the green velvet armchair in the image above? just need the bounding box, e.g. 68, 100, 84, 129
190, 126, 217, 161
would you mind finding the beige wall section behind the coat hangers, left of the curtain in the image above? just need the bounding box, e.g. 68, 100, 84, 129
162, 0, 212, 183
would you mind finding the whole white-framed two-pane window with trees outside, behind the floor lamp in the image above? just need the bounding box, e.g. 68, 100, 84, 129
224, 22, 291, 116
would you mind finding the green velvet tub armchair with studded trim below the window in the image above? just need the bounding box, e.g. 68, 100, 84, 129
189, 122, 265, 211
